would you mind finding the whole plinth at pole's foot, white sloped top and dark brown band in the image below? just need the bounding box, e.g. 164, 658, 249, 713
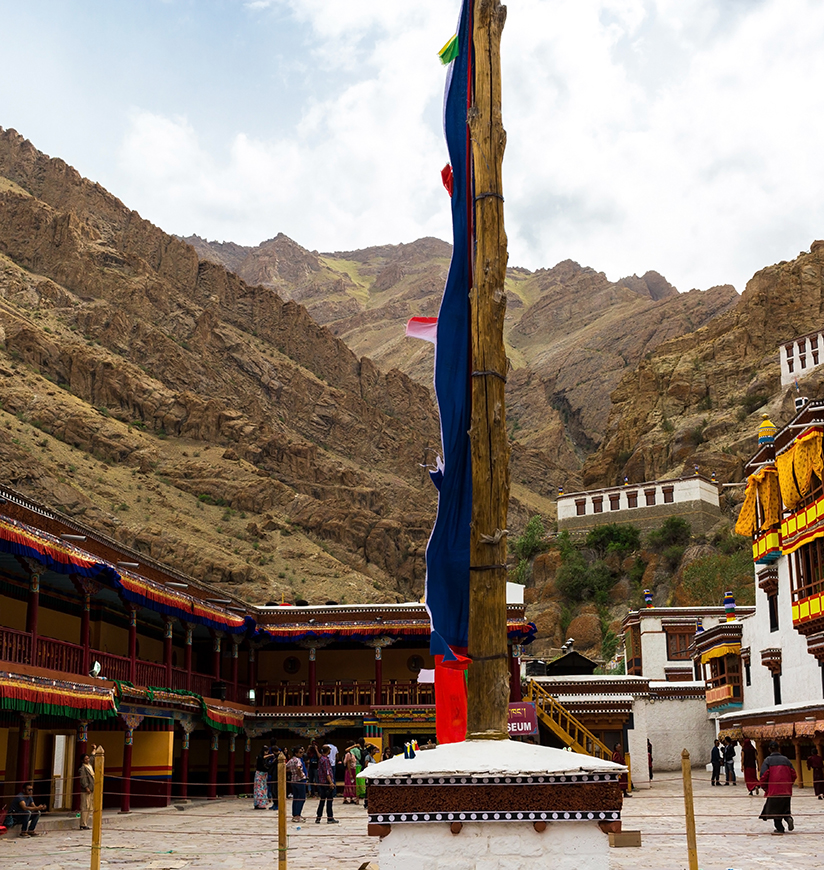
359, 740, 626, 870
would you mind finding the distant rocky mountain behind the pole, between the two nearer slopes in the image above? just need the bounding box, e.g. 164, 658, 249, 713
192, 235, 738, 504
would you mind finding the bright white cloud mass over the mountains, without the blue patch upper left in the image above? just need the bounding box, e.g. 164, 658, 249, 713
116, 0, 824, 290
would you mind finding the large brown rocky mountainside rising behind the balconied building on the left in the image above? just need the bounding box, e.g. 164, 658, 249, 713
0, 129, 448, 602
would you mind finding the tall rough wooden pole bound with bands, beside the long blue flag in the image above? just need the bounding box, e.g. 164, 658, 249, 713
467, 0, 509, 740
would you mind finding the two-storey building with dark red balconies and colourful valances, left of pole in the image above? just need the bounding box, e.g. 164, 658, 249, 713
0, 490, 535, 812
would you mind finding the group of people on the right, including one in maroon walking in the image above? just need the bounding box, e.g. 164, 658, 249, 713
710, 737, 824, 834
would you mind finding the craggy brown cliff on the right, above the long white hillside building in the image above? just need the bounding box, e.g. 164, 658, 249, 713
583, 241, 824, 485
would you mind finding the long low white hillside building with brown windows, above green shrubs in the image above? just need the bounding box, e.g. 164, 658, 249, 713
558, 474, 721, 534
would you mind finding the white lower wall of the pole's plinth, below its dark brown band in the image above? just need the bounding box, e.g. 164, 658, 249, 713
378, 822, 609, 870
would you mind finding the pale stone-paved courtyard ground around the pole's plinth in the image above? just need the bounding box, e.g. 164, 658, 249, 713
0, 770, 824, 870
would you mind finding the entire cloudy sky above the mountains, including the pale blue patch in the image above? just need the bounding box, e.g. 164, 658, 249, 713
0, 0, 824, 291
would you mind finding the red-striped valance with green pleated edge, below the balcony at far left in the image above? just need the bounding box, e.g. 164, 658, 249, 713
0, 671, 117, 721
